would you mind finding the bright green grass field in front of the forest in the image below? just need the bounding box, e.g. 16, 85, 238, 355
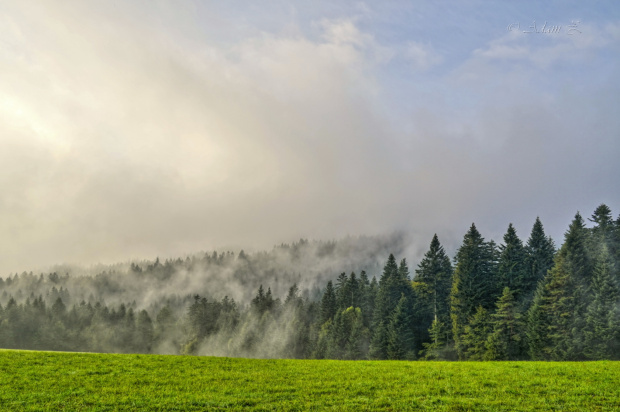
0, 350, 620, 411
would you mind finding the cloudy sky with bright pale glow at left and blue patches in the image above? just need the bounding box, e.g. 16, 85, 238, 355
0, 0, 620, 276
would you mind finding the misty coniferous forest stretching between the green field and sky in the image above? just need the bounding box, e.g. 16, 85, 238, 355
0, 204, 620, 361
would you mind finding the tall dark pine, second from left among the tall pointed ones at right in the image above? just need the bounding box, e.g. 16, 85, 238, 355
450, 224, 498, 358
